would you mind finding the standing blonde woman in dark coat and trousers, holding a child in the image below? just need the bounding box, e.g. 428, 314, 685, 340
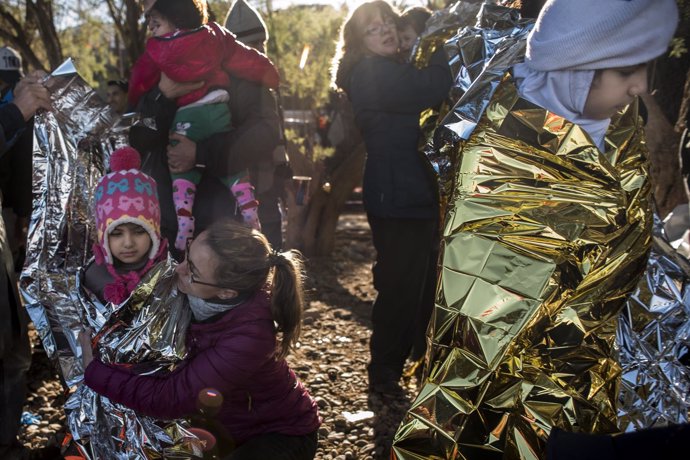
335, 0, 451, 395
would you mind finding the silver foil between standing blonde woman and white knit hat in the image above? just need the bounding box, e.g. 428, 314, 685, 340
415, 1, 534, 214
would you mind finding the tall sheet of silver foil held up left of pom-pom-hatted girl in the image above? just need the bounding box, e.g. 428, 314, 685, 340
20, 60, 127, 386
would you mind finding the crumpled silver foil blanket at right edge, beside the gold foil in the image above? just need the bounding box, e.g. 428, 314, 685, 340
616, 219, 690, 431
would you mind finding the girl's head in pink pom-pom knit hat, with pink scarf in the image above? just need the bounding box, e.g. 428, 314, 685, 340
84, 147, 167, 304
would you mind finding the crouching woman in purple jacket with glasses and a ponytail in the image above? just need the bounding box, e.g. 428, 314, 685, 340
84, 221, 321, 460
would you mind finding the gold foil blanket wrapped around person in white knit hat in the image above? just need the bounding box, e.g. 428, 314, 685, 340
393, 5, 653, 459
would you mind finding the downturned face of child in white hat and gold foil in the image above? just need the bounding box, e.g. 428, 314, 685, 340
582, 64, 647, 120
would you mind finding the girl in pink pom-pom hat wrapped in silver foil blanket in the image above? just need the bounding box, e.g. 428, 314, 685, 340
70, 147, 201, 458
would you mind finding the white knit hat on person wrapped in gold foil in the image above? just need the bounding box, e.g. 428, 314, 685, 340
525, 0, 678, 71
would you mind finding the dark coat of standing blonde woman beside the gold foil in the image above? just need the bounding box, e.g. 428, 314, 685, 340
345, 52, 452, 219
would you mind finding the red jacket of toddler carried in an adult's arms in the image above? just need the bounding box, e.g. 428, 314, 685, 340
128, 22, 280, 107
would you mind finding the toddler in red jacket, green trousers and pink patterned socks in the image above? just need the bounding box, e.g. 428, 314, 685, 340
129, 0, 279, 250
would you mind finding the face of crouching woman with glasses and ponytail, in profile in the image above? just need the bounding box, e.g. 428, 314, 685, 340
175, 233, 227, 299
